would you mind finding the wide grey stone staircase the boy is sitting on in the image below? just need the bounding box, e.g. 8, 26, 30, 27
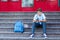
0, 12, 60, 40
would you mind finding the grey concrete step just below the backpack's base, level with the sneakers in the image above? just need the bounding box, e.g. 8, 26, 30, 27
0, 32, 60, 37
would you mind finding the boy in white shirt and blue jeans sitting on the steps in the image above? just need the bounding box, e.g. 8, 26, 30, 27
30, 8, 47, 38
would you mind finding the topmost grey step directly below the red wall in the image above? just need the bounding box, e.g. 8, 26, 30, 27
0, 12, 60, 15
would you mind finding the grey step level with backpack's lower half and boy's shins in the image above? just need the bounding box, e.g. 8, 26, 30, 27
0, 28, 60, 34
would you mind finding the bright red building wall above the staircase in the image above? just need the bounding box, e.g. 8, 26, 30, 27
0, 0, 60, 12
